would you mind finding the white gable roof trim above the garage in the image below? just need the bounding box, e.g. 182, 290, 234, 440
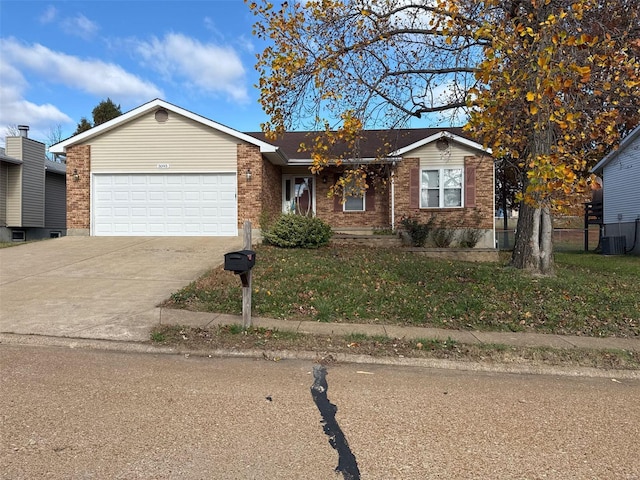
49, 98, 284, 163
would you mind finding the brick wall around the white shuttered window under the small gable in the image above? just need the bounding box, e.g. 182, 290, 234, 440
395, 156, 494, 230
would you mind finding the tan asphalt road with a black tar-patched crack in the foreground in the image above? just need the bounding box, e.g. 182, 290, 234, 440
0, 345, 640, 480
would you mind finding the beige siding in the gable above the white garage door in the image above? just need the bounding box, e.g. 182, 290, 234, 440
87, 111, 238, 173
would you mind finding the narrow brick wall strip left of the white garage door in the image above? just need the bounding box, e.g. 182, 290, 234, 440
67, 145, 91, 234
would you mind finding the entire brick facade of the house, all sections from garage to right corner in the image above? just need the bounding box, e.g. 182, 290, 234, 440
62, 138, 494, 234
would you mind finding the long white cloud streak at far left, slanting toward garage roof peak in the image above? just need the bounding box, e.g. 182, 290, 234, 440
0, 39, 163, 102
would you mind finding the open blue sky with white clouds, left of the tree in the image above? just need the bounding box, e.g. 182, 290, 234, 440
0, 0, 266, 144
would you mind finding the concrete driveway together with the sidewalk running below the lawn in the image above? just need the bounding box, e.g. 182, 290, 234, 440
0, 237, 640, 352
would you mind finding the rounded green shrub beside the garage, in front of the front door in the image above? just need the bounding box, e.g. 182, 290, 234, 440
262, 213, 333, 248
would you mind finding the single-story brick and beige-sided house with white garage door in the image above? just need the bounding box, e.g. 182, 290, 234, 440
50, 99, 495, 248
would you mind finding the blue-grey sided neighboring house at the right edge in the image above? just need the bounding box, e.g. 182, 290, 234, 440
592, 125, 640, 255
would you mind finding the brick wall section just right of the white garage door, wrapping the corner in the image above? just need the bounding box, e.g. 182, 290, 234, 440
238, 145, 282, 228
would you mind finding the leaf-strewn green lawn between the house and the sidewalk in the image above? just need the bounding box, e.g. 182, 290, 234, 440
165, 246, 640, 336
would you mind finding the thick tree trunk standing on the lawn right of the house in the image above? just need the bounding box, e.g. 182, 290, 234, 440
511, 202, 554, 275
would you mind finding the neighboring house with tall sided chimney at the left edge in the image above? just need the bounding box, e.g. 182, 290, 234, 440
0, 125, 66, 241
